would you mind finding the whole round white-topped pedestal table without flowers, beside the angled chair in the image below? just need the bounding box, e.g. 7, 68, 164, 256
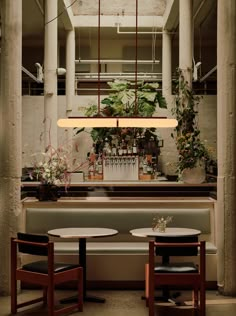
48, 227, 118, 303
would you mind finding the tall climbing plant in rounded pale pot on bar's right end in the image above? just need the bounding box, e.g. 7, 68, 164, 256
171, 69, 209, 183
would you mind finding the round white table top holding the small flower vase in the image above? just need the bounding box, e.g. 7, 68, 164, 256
130, 227, 201, 237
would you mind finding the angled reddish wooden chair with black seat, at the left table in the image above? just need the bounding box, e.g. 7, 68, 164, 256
11, 233, 83, 316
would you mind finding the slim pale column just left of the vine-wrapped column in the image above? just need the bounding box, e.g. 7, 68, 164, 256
162, 30, 172, 98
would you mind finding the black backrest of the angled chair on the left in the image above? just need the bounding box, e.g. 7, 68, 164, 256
17, 232, 49, 256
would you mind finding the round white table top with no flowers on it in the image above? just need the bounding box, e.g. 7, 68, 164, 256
48, 227, 118, 238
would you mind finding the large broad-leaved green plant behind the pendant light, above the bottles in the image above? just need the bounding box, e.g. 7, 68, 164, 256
76, 80, 167, 151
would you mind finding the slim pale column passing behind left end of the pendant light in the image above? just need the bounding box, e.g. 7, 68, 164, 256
66, 29, 75, 143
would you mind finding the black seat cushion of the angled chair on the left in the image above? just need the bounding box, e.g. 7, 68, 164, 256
22, 260, 79, 274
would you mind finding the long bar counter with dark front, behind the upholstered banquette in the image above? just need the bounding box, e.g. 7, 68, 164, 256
21, 180, 217, 198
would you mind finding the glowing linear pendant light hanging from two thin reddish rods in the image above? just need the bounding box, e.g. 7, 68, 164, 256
57, 0, 178, 128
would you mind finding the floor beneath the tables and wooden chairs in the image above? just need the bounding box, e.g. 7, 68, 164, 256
0, 290, 236, 316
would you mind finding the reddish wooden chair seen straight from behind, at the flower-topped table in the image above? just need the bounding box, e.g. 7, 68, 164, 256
145, 240, 206, 316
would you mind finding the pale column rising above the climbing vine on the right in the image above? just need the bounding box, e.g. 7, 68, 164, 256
179, 0, 193, 87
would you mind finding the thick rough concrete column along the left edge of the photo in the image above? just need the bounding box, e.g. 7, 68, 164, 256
0, 0, 22, 295
